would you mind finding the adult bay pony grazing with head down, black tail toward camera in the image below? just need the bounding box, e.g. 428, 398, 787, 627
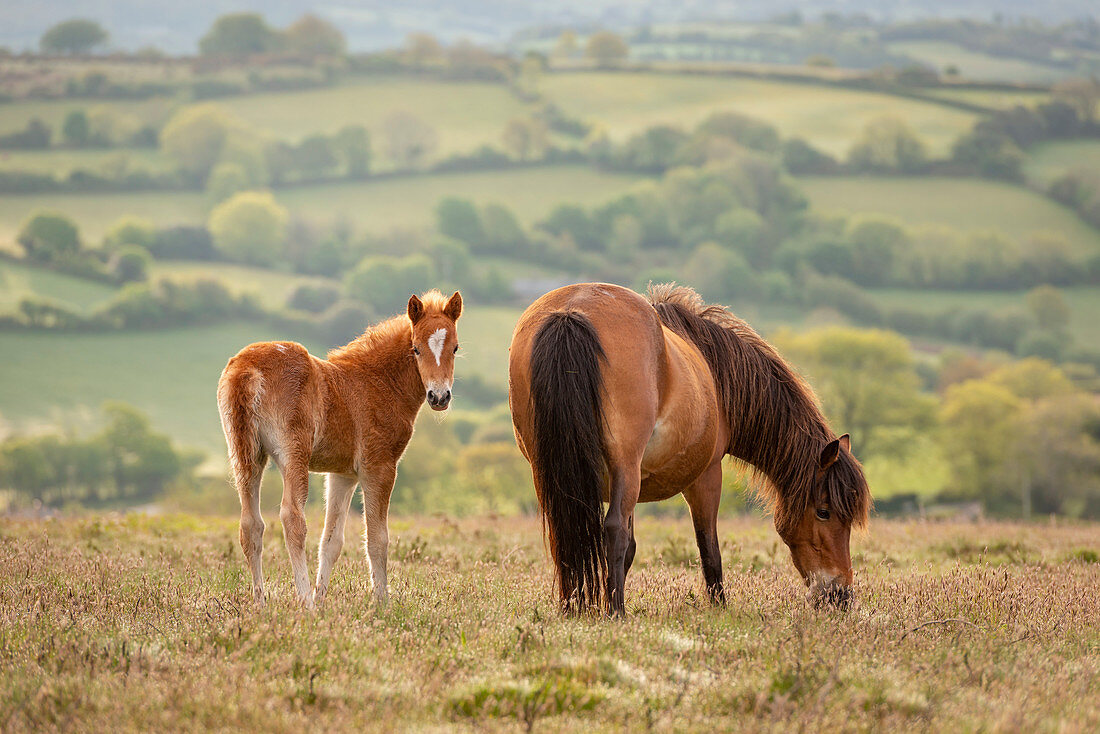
508, 283, 871, 614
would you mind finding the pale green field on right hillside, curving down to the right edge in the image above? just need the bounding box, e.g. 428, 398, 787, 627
800, 177, 1100, 252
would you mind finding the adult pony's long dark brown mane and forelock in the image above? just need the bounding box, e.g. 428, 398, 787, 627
647, 283, 871, 534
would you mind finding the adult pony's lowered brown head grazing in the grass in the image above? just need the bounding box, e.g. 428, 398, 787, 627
776, 434, 870, 606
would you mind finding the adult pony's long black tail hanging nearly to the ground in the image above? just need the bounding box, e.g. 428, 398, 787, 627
531, 311, 607, 609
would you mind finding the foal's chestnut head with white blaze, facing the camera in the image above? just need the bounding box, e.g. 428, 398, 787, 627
408, 291, 462, 410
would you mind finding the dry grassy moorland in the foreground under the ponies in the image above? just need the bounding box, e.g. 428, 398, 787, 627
0, 515, 1100, 732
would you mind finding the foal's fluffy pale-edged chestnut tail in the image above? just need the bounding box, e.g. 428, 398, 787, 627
218, 360, 263, 492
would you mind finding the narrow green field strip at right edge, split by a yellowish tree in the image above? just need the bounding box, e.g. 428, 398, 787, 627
869, 286, 1100, 346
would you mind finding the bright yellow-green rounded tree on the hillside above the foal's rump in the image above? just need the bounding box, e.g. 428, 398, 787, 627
208, 191, 288, 265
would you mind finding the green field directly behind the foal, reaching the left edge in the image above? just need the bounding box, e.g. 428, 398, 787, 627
0, 303, 519, 456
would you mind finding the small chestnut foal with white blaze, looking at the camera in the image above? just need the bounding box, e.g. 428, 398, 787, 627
218, 291, 462, 607
